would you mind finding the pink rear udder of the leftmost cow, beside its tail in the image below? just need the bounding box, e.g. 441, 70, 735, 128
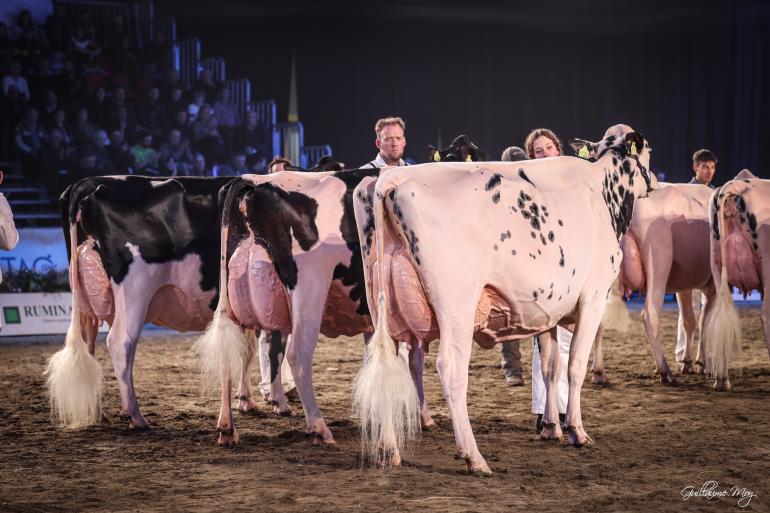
76, 239, 115, 322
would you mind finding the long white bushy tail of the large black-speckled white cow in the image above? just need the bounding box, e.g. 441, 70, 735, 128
353, 178, 420, 465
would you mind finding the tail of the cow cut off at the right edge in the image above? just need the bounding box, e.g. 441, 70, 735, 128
703, 186, 741, 391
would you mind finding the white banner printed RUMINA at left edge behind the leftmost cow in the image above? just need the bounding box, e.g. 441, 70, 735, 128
0, 292, 109, 337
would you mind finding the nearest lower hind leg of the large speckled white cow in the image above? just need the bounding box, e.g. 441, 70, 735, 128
436, 316, 492, 474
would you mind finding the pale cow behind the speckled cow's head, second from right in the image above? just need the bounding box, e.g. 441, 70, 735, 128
593, 183, 715, 384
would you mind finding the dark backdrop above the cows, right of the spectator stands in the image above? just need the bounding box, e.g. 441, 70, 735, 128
156, 0, 770, 184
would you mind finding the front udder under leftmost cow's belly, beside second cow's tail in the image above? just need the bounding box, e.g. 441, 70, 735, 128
145, 285, 211, 331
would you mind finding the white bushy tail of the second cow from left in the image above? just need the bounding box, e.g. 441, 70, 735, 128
193, 198, 255, 389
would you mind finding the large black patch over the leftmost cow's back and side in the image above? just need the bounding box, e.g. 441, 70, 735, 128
67, 176, 232, 310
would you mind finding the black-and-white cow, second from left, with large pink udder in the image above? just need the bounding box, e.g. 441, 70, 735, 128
196, 168, 435, 445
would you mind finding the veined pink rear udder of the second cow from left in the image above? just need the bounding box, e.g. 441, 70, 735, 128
227, 238, 291, 333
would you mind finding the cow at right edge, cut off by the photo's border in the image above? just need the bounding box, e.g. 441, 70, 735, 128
703, 170, 770, 390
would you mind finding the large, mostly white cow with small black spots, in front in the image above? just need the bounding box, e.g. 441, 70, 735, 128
354, 125, 657, 473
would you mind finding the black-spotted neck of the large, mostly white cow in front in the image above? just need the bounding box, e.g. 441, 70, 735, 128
595, 150, 644, 242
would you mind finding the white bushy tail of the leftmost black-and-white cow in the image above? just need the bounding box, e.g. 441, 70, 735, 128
44, 223, 102, 429
